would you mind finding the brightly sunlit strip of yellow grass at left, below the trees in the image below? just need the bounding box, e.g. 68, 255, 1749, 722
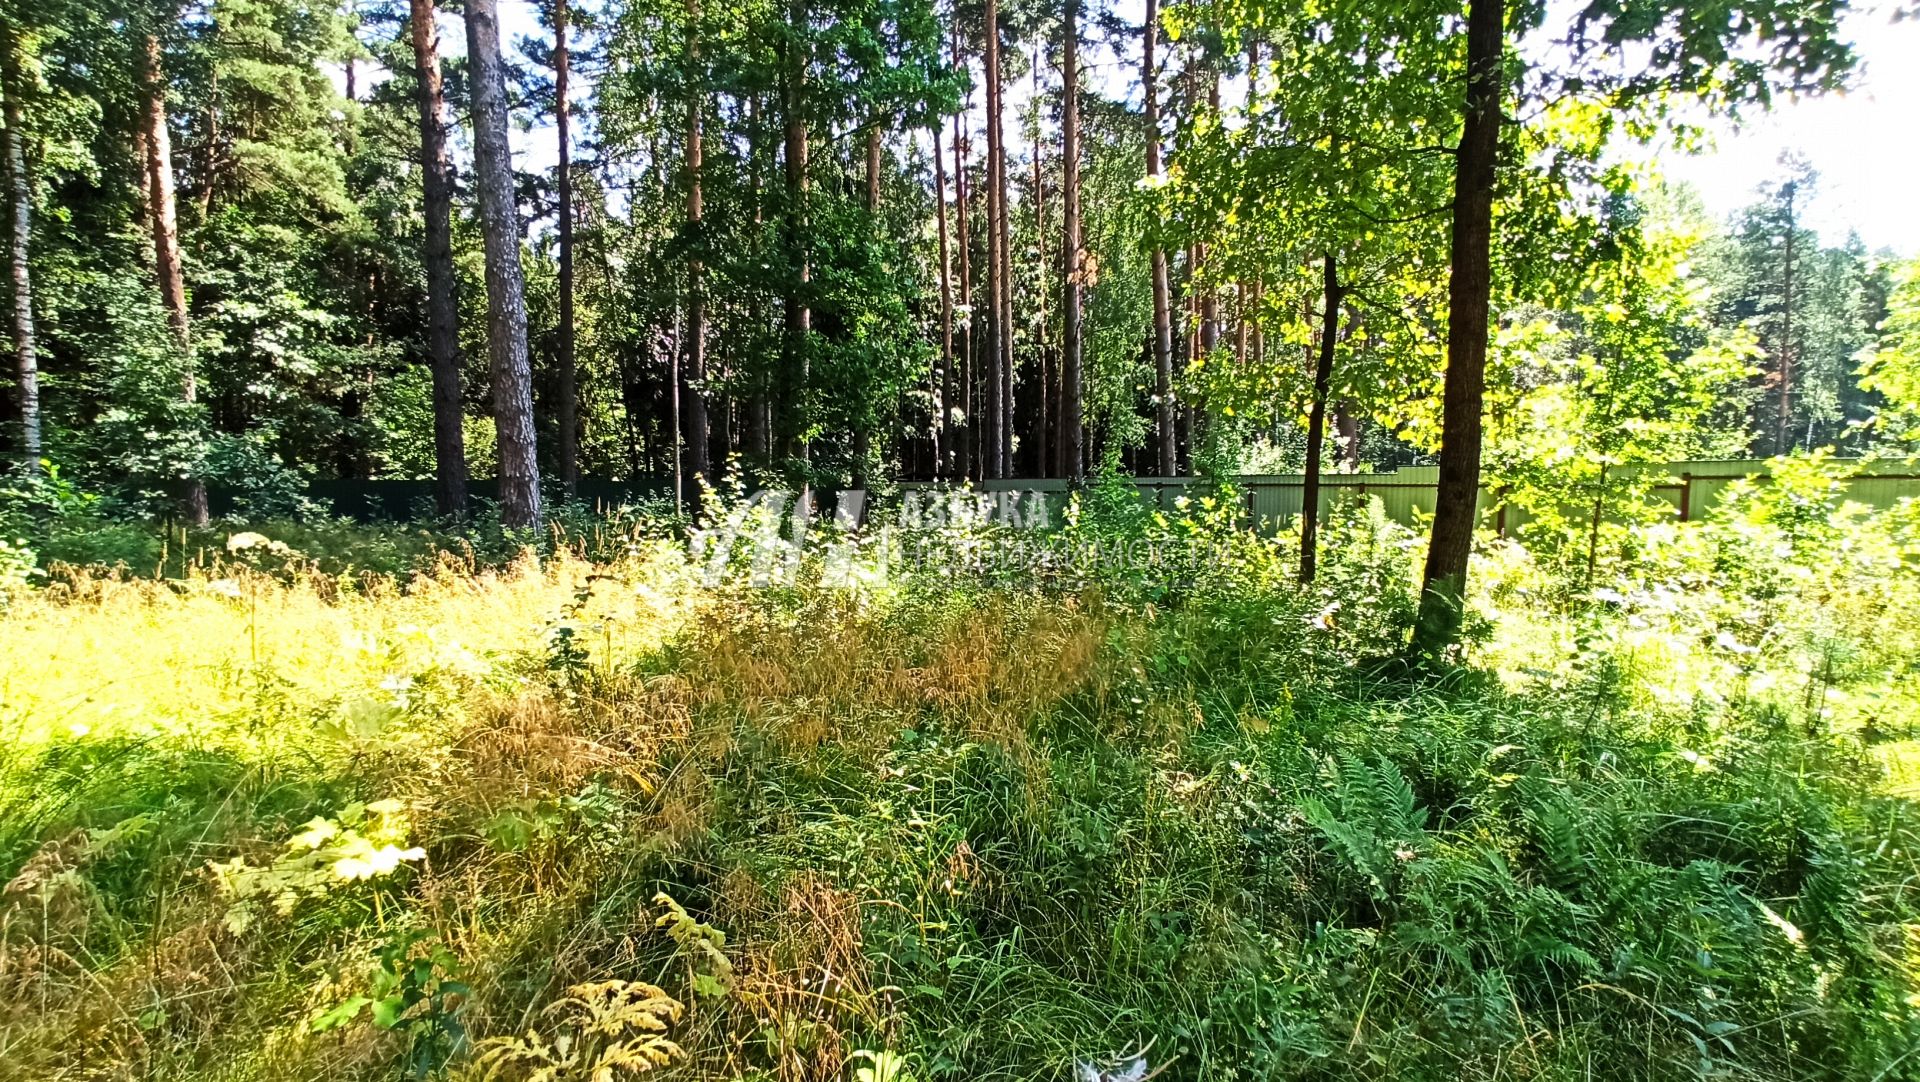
0, 547, 695, 750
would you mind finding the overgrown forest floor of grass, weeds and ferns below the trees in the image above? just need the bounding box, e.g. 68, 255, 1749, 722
0, 491, 1920, 1082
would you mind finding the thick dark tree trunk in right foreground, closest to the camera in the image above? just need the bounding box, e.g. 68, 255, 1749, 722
1413, 0, 1505, 658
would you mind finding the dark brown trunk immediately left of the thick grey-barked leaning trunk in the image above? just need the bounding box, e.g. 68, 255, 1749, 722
409, 0, 467, 514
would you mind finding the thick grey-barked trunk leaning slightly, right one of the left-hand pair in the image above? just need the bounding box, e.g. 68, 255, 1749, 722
467, 0, 540, 526
